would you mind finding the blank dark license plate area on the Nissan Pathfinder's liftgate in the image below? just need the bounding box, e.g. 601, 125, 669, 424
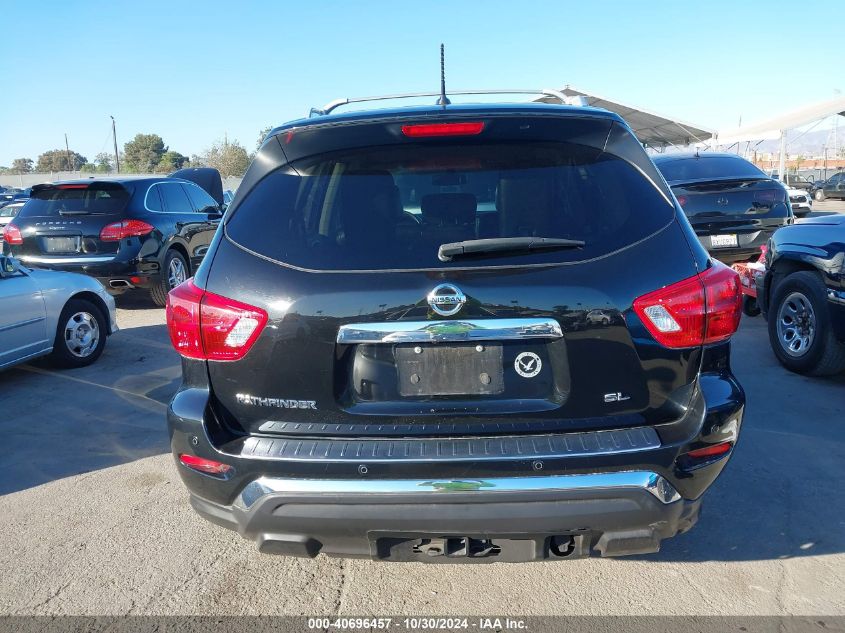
393, 342, 505, 397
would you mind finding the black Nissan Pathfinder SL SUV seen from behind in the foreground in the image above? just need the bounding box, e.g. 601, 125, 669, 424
167, 99, 745, 562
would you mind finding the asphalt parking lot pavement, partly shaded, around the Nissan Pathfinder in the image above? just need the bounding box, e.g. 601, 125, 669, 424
0, 220, 845, 615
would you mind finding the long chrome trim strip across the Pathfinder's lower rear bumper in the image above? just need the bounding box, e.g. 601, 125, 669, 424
235, 471, 681, 510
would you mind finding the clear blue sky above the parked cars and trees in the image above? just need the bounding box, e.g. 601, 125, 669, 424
0, 0, 845, 166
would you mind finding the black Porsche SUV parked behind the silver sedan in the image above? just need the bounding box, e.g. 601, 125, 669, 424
3, 168, 223, 306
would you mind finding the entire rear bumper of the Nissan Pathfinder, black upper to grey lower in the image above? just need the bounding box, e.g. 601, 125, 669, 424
168, 358, 745, 562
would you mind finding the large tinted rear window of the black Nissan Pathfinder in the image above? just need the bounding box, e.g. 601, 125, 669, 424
226, 142, 674, 270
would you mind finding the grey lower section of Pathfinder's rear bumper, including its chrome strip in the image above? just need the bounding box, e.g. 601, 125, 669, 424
191, 471, 700, 563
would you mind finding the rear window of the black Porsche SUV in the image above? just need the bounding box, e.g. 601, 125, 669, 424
19, 183, 130, 218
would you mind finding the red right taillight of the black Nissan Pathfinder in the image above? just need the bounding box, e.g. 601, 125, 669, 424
634, 261, 742, 348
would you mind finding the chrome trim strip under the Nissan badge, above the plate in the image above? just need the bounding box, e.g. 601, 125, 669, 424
337, 319, 563, 345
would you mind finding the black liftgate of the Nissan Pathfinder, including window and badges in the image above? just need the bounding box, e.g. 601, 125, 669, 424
204, 115, 701, 437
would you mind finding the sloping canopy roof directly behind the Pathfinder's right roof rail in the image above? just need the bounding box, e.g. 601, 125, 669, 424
537, 85, 715, 149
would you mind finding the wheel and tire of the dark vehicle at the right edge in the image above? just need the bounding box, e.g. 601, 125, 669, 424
768, 271, 845, 376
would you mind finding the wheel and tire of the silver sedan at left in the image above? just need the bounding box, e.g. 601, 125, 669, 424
49, 299, 109, 369
